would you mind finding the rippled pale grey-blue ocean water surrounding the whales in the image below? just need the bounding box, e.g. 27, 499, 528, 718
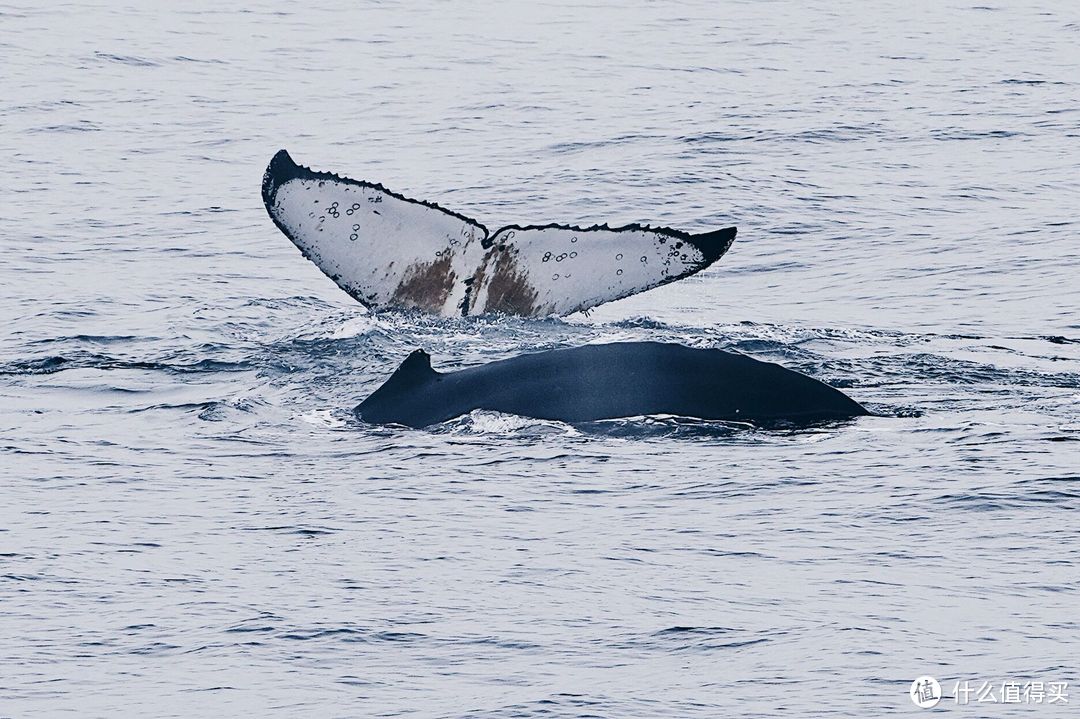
0, 0, 1080, 719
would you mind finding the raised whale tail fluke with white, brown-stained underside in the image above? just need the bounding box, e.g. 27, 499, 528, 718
262, 150, 735, 316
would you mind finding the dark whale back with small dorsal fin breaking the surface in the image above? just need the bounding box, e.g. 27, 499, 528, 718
355, 342, 869, 428
